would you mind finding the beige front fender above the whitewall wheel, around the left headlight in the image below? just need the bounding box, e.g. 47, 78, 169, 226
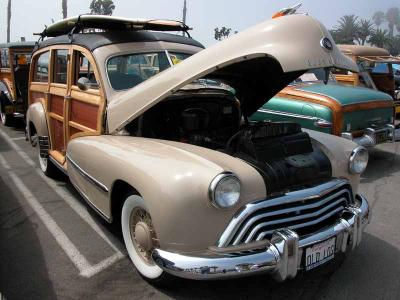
67, 136, 266, 252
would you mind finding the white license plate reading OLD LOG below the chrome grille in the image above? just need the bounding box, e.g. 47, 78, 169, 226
305, 237, 336, 271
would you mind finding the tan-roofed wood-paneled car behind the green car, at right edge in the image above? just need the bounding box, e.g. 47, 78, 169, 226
334, 45, 400, 114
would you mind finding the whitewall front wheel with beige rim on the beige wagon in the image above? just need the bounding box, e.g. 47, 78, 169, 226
121, 195, 165, 281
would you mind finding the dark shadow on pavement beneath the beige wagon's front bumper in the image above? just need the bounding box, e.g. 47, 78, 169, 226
155, 233, 400, 299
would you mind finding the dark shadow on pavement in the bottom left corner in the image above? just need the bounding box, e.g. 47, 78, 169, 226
0, 178, 56, 299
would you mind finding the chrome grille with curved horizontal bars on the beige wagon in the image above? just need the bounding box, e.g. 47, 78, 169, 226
218, 179, 353, 247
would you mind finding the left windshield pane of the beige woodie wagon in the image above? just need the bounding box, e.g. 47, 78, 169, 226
107, 52, 170, 90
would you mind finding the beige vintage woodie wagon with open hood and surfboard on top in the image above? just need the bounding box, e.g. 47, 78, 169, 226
27, 15, 369, 281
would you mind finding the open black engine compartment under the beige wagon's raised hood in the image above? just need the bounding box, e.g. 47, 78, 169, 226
126, 90, 332, 194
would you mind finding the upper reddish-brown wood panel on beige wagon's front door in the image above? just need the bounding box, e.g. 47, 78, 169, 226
70, 99, 99, 130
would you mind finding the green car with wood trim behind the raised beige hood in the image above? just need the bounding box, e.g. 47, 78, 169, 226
251, 69, 400, 147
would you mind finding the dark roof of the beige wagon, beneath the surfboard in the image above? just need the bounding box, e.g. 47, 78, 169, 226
36, 31, 204, 51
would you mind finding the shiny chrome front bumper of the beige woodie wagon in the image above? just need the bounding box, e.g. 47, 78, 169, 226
153, 195, 370, 281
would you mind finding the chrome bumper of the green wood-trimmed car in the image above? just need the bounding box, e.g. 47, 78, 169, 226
342, 124, 400, 148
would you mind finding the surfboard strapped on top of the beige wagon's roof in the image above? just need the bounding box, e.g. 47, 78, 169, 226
40, 15, 191, 37
